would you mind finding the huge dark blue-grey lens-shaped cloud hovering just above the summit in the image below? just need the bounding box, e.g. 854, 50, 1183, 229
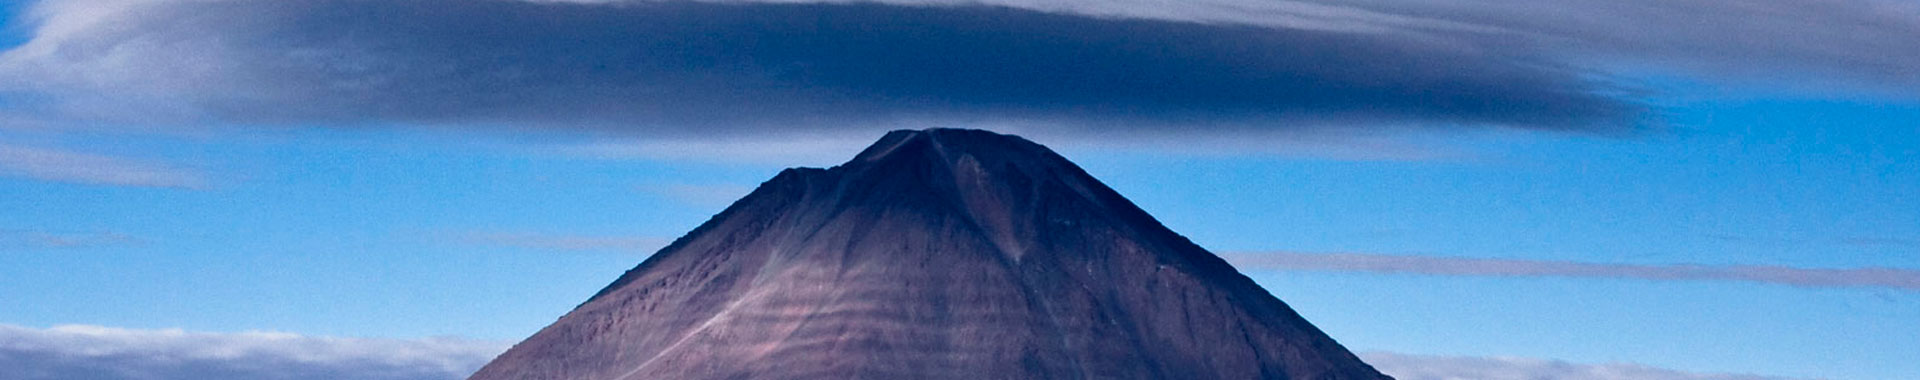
0, 0, 1644, 136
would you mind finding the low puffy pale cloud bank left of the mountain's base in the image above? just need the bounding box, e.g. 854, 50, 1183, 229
0, 324, 507, 380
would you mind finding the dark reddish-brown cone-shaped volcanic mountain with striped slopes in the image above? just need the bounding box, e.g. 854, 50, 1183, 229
470, 129, 1390, 380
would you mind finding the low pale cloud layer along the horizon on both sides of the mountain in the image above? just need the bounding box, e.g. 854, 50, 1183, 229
0, 324, 1797, 380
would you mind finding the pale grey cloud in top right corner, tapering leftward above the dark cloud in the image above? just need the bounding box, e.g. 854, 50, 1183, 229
864, 0, 1920, 98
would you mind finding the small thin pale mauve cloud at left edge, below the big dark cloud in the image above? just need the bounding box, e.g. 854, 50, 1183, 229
0, 144, 207, 188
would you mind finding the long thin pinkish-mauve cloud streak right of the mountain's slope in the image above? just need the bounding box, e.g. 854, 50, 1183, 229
1221, 251, 1920, 292
